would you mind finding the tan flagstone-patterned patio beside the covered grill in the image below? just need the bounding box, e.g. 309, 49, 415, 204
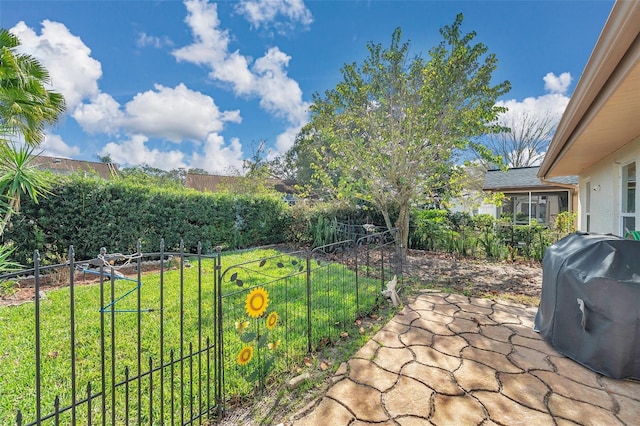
292, 293, 640, 426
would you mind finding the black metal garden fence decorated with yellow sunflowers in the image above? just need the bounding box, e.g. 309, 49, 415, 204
0, 232, 402, 425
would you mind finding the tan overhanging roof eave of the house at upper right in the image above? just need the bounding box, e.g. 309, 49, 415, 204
538, 0, 640, 178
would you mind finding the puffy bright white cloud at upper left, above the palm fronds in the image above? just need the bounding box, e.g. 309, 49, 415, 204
10, 20, 102, 111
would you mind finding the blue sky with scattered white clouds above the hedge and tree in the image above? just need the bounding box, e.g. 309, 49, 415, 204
0, 0, 613, 174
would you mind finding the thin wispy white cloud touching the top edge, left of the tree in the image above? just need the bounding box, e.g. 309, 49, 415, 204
236, 0, 313, 33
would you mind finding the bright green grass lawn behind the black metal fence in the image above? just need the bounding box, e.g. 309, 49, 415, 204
0, 250, 381, 424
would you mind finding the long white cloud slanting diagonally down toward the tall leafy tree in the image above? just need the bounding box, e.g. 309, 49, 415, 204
173, 0, 308, 148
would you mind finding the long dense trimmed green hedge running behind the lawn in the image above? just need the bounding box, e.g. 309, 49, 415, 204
4, 176, 291, 265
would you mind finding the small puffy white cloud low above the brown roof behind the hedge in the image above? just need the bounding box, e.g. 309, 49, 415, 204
189, 134, 243, 174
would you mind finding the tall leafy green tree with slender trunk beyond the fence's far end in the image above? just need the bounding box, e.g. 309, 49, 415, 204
294, 14, 510, 255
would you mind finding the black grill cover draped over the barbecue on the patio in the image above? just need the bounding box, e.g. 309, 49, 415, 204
534, 232, 640, 379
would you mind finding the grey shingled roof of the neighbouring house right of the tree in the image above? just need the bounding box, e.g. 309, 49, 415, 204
482, 166, 578, 192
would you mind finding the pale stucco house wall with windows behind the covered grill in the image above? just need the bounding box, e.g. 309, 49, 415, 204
578, 138, 640, 235
